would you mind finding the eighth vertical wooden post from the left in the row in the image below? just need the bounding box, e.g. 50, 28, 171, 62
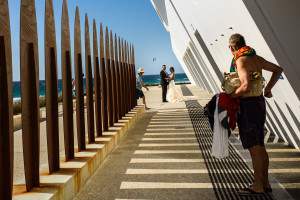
100, 23, 108, 131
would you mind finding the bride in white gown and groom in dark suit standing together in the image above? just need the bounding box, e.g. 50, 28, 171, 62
160, 65, 197, 103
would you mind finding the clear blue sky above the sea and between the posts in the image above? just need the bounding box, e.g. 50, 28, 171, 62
8, 0, 183, 81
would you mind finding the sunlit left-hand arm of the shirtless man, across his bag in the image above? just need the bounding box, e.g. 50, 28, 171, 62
231, 57, 251, 98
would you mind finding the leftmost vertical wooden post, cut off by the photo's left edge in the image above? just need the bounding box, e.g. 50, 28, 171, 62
0, 0, 14, 200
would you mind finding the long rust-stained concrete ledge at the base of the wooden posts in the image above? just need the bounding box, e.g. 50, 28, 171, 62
13, 106, 145, 200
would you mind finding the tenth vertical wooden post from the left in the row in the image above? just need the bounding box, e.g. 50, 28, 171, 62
110, 31, 118, 124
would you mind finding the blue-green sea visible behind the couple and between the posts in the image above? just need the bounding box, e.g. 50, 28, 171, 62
13, 73, 189, 101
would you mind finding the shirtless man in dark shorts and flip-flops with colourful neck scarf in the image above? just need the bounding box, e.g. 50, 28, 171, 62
229, 34, 283, 196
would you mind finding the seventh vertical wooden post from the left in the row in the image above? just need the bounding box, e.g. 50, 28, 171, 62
93, 19, 102, 136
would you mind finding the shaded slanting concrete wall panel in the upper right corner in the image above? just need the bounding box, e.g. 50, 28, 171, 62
244, 0, 300, 98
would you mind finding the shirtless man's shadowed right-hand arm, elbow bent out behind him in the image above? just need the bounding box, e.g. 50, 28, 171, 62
259, 56, 283, 98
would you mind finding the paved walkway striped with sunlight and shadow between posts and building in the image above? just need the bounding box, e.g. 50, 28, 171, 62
76, 86, 300, 200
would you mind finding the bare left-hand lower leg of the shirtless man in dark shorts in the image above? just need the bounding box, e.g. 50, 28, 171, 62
239, 145, 264, 193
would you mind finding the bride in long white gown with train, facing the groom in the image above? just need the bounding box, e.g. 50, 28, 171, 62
167, 67, 197, 103
